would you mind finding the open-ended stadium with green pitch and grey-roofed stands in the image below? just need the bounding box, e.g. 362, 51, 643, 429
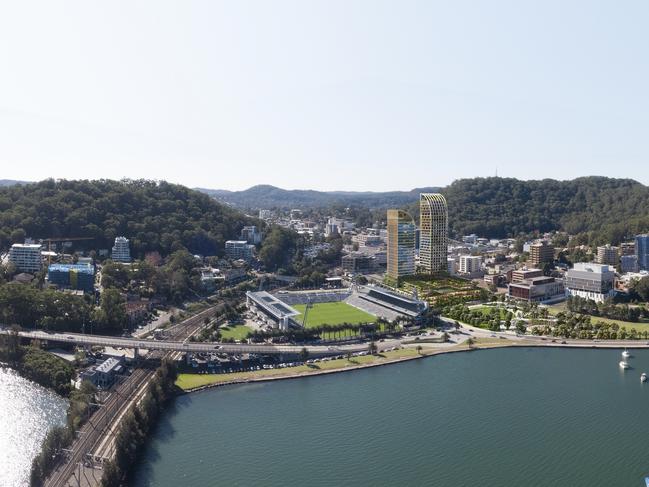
246, 286, 428, 330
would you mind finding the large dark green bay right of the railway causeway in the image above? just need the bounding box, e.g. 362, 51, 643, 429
132, 348, 649, 487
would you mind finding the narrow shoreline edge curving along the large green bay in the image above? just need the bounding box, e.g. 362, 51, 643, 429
177, 341, 649, 396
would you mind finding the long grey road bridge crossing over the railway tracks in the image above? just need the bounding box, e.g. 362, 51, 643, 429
0, 328, 367, 356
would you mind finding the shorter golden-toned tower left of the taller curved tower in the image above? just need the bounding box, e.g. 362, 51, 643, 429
388, 210, 417, 279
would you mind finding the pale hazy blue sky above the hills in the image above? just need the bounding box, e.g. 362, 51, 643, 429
0, 0, 649, 191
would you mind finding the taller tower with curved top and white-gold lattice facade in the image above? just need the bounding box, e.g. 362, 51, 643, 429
419, 193, 448, 274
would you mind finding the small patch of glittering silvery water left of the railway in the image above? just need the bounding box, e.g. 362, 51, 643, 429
0, 368, 68, 487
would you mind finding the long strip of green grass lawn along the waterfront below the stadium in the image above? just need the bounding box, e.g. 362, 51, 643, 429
176, 348, 426, 390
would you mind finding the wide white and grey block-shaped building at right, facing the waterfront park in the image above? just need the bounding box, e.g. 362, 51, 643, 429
565, 262, 615, 302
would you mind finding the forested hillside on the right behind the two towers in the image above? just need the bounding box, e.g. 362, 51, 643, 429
440, 177, 649, 243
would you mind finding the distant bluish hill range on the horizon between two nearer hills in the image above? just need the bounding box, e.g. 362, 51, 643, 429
198, 185, 438, 210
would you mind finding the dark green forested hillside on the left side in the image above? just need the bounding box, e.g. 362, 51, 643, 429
0, 179, 249, 257
